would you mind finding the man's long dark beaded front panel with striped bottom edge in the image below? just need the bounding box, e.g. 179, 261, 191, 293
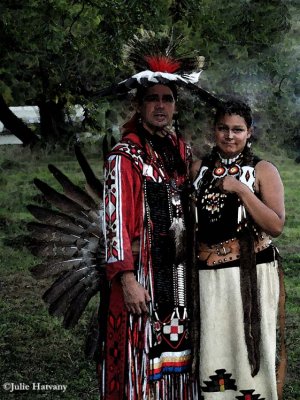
144, 135, 191, 381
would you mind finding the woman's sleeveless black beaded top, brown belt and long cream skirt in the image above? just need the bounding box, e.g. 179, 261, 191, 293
194, 152, 279, 400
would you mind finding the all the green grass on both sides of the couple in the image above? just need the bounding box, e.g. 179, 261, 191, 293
0, 147, 300, 400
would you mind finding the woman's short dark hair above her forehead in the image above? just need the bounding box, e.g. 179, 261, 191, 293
214, 99, 253, 128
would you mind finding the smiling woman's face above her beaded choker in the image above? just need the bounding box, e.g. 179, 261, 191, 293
215, 114, 251, 158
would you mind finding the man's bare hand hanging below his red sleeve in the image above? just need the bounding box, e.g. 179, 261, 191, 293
121, 271, 151, 315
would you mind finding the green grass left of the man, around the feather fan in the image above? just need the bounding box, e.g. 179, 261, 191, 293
0, 147, 102, 400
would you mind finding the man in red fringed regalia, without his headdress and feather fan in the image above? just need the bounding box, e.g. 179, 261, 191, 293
103, 80, 195, 399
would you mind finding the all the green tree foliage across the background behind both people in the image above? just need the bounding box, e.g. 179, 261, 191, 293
0, 0, 300, 151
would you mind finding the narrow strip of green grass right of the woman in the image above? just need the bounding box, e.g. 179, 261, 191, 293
250, 149, 300, 400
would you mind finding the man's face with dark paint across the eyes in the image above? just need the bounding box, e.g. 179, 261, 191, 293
139, 84, 175, 134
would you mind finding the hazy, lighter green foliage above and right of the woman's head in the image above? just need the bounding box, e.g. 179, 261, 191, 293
182, 0, 300, 150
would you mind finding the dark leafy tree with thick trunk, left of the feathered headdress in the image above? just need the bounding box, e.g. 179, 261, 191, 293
0, 0, 171, 147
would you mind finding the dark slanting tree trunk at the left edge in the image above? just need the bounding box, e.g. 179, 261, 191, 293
0, 94, 39, 147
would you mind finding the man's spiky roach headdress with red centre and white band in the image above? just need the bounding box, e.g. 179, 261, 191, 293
97, 31, 220, 107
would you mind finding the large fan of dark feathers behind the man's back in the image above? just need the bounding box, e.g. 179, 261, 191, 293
27, 146, 108, 357
